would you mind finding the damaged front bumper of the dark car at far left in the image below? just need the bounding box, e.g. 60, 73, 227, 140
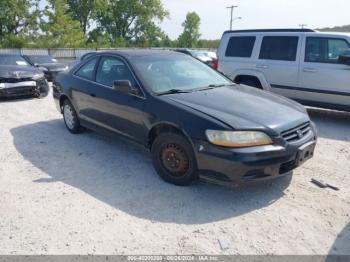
0, 78, 49, 98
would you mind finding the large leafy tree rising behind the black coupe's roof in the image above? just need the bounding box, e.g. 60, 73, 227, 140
94, 0, 168, 43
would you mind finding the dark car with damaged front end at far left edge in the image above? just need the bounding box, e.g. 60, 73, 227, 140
0, 55, 49, 97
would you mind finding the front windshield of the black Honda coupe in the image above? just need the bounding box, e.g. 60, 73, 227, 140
132, 54, 233, 93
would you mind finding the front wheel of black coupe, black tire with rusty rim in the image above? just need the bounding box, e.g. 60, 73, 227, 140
151, 133, 198, 186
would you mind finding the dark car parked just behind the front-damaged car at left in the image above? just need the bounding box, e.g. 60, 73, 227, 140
23, 55, 68, 81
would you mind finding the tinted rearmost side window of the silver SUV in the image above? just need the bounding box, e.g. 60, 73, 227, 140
225, 36, 256, 57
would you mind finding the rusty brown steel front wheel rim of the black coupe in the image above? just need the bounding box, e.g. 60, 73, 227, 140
160, 143, 190, 177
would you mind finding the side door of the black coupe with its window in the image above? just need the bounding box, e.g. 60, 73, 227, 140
89, 56, 147, 142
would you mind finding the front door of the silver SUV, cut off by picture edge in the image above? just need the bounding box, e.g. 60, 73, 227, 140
298, 36, 350, 108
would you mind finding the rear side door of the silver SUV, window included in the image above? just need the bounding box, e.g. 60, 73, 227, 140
256, 35, 301, 97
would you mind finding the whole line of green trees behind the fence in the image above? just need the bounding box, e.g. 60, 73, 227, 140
0, 0, 219, 48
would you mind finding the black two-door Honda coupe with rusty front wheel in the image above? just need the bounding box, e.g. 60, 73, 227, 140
53, 50, 316, 185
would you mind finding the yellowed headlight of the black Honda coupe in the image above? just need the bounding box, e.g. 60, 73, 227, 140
205, 130, 273, 147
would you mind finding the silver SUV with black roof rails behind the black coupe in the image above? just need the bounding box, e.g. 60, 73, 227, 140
218, 29, 350, 111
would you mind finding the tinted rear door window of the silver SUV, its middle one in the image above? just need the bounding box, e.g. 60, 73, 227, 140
259, 36, 299, 61
